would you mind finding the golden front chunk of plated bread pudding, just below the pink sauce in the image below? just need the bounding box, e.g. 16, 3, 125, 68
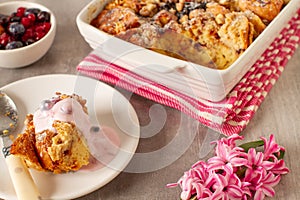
35, 121, 89, 173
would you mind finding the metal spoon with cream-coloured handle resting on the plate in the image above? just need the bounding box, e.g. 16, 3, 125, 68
0, 91, 41, 200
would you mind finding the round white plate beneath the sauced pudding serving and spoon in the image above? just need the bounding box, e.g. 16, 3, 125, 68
0, 74, 140, 200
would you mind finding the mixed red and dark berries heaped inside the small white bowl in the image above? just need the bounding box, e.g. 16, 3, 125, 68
0, 7, 51, 50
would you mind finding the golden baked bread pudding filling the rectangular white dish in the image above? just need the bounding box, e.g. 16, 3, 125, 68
91, 0, 288, 69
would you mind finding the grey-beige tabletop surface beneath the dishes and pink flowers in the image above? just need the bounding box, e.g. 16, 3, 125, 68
0, 0, 300, 200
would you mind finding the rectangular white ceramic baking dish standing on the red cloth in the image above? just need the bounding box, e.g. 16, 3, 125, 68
76, 0, 300, 101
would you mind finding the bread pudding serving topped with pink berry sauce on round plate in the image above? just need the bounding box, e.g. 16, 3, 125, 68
11, 93, 90, 173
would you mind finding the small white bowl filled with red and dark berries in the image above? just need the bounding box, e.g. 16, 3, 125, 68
0, 1, 56, 68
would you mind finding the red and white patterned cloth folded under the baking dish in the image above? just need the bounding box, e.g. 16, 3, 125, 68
77, 10, 300, 136
